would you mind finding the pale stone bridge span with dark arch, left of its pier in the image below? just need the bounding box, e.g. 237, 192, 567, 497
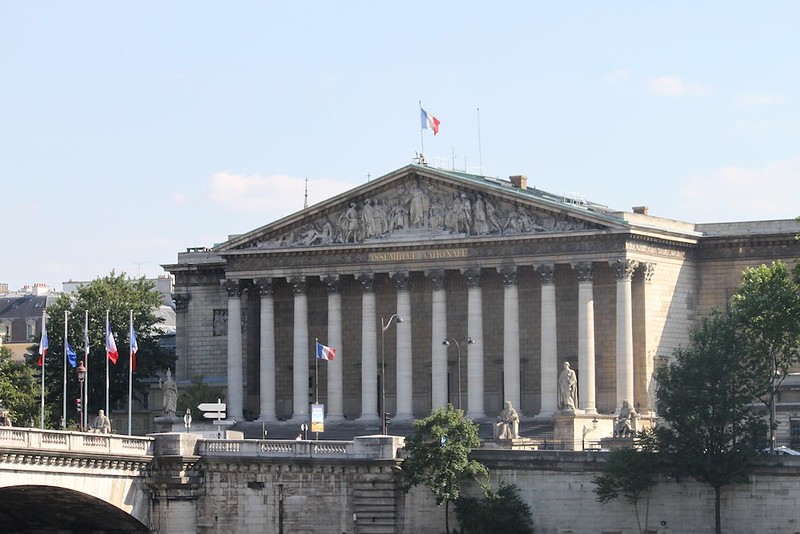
0, 428, 153, 532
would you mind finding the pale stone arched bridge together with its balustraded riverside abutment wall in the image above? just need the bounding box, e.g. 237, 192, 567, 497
0, 428, 402, 534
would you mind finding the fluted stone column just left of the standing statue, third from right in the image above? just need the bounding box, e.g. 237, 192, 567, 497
537, 263, 558, 417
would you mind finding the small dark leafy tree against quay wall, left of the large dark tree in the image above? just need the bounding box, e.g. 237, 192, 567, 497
593, 447, 656, 532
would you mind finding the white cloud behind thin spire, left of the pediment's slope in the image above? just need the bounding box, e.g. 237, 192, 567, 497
208, 172, 353, 216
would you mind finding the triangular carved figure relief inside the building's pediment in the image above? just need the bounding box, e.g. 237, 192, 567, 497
246, 180, 597, 248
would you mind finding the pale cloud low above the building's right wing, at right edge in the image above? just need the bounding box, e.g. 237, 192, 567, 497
681, 157, 800, 222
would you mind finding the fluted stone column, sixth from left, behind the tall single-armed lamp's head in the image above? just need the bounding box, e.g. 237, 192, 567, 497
390, 271, 414, 421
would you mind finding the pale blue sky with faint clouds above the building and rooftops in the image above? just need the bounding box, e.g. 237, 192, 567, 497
0, 0, 800, 290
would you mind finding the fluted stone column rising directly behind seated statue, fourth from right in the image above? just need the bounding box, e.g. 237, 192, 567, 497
498, 266, 522, 412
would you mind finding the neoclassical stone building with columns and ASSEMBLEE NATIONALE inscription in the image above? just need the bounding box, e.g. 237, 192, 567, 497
165, 165, 800, 424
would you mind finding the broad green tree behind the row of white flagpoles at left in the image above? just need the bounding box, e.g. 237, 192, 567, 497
31, 271, 175, 430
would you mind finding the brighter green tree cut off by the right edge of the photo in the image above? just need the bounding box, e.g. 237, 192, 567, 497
731, 261, 800, 449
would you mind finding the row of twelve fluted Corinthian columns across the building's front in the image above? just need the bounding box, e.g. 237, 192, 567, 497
223, 260, 639, 423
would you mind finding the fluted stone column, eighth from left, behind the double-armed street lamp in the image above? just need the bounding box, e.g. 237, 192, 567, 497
461, 267, 486, 419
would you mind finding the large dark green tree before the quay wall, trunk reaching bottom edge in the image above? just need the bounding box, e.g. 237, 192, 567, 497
656, 310, 766, 534
